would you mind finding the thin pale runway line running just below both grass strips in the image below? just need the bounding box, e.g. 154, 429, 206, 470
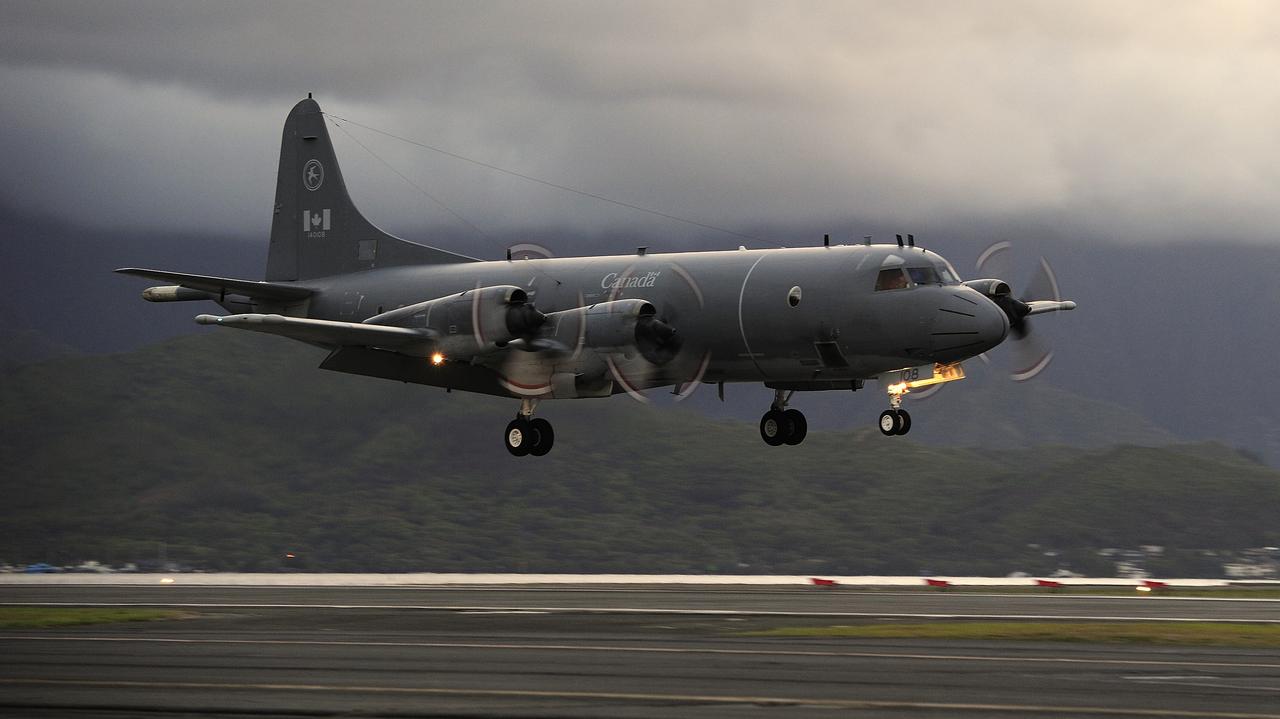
0, 635, 1280, 669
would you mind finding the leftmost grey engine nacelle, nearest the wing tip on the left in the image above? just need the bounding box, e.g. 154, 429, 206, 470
365, 285, 547, 358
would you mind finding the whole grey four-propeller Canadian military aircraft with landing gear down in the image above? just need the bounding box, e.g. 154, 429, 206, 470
116, 95, 1075, 455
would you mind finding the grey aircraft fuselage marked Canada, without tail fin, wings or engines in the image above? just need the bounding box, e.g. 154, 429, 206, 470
294, 246, 1009, 397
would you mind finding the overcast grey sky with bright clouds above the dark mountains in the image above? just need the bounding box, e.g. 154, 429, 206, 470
0, 0, 1280, 242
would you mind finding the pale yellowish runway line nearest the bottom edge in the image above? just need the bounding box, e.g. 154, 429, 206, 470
0, 678, 1280, 719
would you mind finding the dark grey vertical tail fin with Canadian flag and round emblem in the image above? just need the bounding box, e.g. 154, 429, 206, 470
266, 96, 475, 281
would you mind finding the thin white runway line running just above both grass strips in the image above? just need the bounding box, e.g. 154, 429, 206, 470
0, 601, 1280, 624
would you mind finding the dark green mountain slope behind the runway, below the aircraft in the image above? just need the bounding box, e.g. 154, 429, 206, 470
0, 331, 1280, 574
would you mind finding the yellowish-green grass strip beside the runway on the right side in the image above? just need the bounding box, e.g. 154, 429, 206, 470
739, 622, 1280, 649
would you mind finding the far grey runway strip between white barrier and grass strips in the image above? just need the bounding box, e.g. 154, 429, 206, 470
0, 583, 1280, 623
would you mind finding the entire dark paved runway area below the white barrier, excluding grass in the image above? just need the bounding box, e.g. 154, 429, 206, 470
0, 586, 1280, 718
